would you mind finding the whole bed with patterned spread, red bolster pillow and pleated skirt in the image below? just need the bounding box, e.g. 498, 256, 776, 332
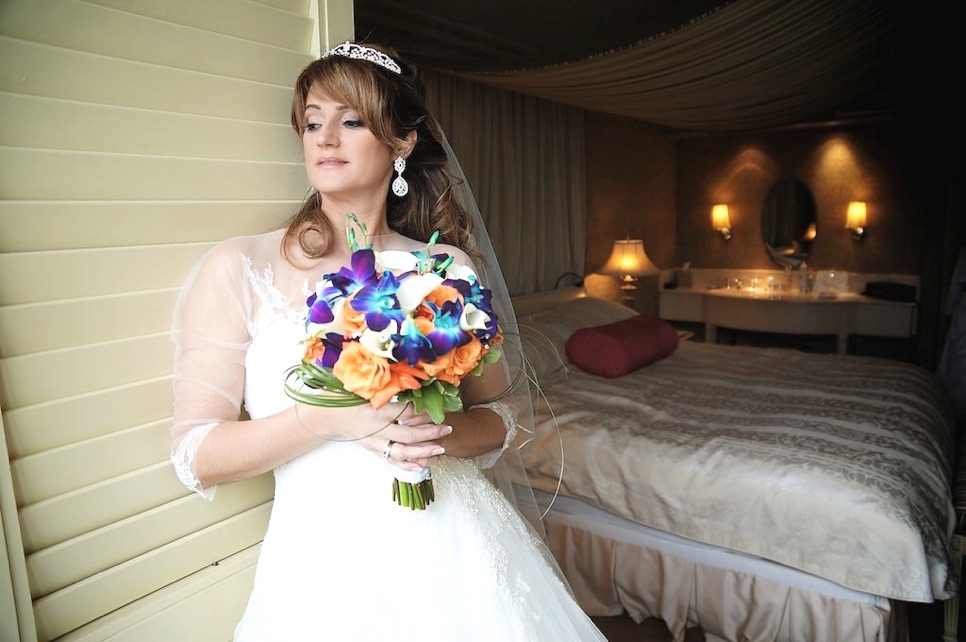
514, 288, 959, 642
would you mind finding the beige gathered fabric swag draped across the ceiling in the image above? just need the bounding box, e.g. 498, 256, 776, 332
452, 0, 902, 131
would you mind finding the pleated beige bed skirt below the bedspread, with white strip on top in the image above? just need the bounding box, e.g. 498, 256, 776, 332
538, 494, 907, 642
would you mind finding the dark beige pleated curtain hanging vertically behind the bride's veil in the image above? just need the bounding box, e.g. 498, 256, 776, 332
426, 73, 587, 294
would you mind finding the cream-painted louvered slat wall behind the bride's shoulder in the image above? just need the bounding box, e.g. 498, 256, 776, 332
0, 0, 336, 642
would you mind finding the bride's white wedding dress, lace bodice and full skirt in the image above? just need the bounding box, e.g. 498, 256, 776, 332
224, 249, 606, 642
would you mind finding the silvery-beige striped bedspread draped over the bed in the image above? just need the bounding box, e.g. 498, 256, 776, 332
523, 342, 958, 601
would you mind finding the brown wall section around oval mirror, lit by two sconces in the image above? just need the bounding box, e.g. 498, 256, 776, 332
677, 125, 927, 274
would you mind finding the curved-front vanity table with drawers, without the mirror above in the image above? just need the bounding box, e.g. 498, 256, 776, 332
658, 288, 917, 354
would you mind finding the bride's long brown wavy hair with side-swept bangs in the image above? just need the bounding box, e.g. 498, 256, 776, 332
282, 44, 481, 261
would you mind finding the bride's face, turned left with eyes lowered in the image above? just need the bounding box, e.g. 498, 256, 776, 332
302, 89, 393, 198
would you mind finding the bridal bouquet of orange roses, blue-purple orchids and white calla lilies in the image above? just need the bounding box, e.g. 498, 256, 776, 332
285, 214, 503, 510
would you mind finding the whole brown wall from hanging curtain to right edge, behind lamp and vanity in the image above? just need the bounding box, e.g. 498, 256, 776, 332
586, 114, 956, 367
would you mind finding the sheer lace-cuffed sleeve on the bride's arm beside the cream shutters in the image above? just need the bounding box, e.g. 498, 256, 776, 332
171, 239, 253, 500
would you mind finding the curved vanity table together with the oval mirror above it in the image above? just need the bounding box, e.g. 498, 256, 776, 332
658, 177, 919, 354
